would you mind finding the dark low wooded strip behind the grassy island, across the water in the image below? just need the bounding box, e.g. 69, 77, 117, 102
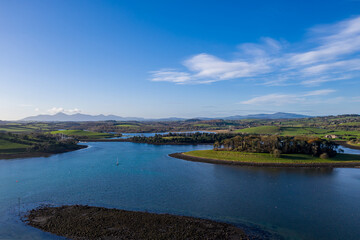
128, 132, 234, 144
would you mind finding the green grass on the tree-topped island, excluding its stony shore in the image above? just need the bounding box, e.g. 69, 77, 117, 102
184, 150, 360, 163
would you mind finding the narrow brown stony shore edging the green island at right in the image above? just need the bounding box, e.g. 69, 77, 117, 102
169, 153, 360, 168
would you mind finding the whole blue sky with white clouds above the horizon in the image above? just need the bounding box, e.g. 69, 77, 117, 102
0, 0, 360, 120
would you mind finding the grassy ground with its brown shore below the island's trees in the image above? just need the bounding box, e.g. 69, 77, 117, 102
169, 150, 360, 167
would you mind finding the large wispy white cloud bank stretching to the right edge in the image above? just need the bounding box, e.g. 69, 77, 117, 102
151, 16, 360, 86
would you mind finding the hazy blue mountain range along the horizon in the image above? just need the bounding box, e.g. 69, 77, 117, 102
20, 112, 310, 122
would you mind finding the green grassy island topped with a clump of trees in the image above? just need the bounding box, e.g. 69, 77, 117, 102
169, 135, 360, 167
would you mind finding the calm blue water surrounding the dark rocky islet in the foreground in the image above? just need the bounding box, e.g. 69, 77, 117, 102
0, 142, 360, 239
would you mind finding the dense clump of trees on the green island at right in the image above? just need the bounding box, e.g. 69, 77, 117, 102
214, 135, 338, 158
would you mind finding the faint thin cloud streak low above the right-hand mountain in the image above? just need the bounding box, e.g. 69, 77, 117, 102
240, 89, 336, 106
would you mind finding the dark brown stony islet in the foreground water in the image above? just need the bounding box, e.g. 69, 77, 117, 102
25, 205, 249, 240
